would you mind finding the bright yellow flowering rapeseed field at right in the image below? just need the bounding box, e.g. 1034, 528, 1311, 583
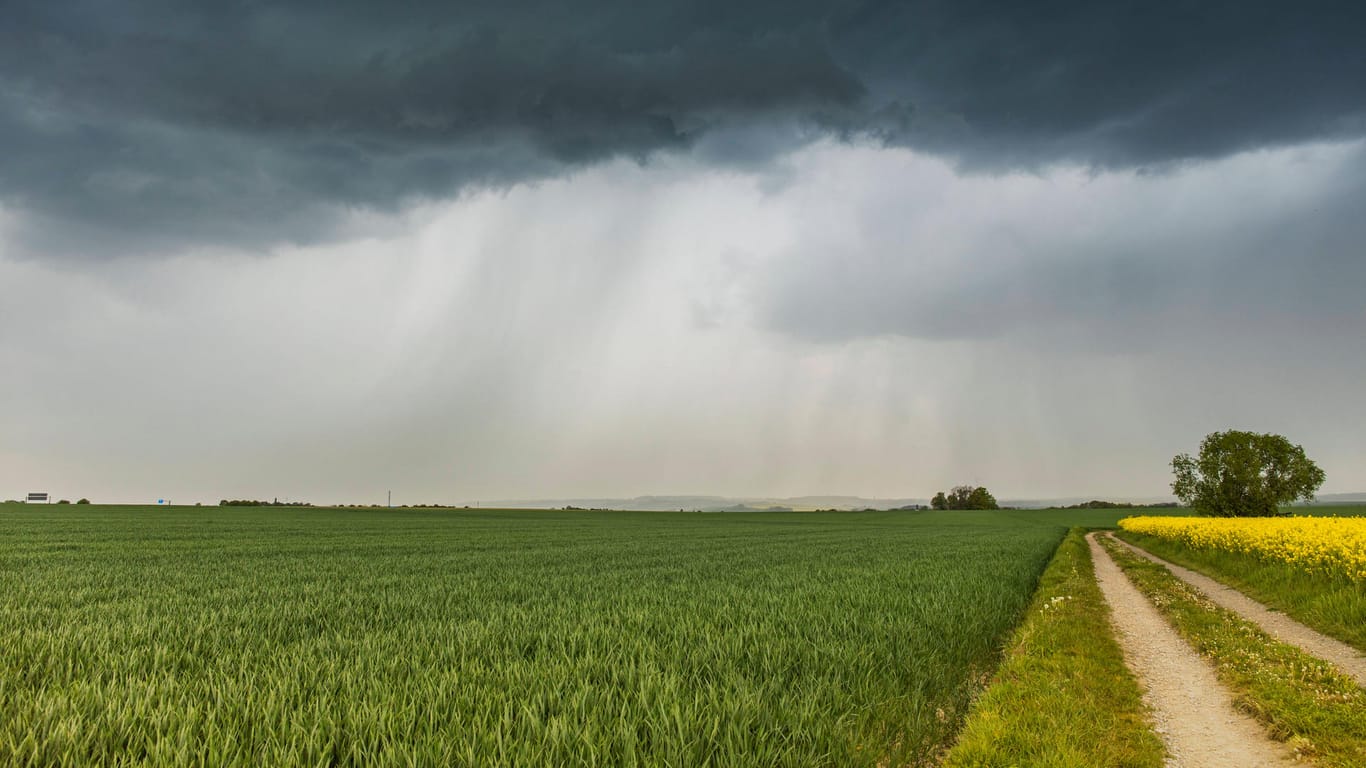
1119, 517, 1366, 581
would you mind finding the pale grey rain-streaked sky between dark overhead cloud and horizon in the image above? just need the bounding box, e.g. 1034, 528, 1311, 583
0, 141, 1366, 503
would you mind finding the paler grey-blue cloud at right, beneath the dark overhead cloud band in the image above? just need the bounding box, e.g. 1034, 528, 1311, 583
761, 142, 1366, 345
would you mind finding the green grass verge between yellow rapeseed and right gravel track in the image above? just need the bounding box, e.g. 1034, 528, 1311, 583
1120, 530, 1366, 652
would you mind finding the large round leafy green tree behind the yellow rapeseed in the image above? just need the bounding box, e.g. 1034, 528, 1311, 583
1172, 429, 1324, 518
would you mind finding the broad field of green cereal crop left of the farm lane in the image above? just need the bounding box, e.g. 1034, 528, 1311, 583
0, 507, 1064, 768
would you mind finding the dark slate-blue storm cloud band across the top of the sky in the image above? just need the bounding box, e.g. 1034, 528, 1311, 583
0, 0, 1366, 253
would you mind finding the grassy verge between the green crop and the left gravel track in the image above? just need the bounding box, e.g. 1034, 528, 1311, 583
944, 529, 1164, 768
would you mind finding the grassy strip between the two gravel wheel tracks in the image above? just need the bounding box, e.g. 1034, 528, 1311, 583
1101, 537, 1366, 768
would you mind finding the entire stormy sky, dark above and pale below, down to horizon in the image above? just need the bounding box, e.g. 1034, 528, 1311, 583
0, 0, 1366, 503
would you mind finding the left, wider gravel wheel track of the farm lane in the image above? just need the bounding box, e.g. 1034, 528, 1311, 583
1086, 533, 1299, 768
